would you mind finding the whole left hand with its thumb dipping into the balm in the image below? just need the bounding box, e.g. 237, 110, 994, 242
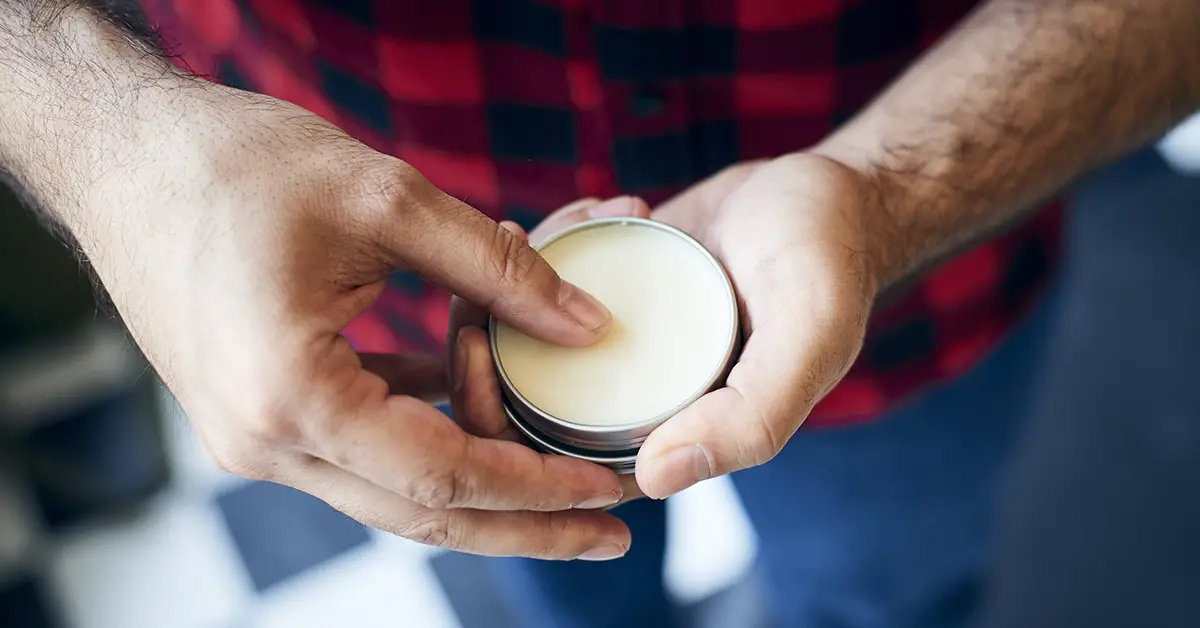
64, 85, 630, 558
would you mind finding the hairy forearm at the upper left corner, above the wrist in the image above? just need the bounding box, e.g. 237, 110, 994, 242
0, 0, 191, 228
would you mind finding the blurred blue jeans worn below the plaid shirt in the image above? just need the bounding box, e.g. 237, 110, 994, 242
490, 291, 1054, 628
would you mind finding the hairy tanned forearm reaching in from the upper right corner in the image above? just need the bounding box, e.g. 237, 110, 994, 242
815, 0, 1200, 287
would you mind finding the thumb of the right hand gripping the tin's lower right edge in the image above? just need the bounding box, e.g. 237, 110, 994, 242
636, 265, 869, 498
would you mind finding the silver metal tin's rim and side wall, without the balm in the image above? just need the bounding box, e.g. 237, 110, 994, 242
488, 217, 740, 473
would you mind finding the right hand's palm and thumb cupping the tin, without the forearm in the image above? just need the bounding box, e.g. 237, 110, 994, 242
637, 155, 878, 498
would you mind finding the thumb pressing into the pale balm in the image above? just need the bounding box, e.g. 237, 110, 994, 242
367, 164, 612, 346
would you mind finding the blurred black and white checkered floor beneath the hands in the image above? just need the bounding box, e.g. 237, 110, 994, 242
0, 393, 757, 628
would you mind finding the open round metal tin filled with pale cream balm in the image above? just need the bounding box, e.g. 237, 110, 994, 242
490, 219, 739, 473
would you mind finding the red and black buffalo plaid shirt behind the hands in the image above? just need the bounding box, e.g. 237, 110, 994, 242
143, 0, 1060, 425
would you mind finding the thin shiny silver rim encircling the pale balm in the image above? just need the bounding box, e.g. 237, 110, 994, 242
487, 217, 742, 437
